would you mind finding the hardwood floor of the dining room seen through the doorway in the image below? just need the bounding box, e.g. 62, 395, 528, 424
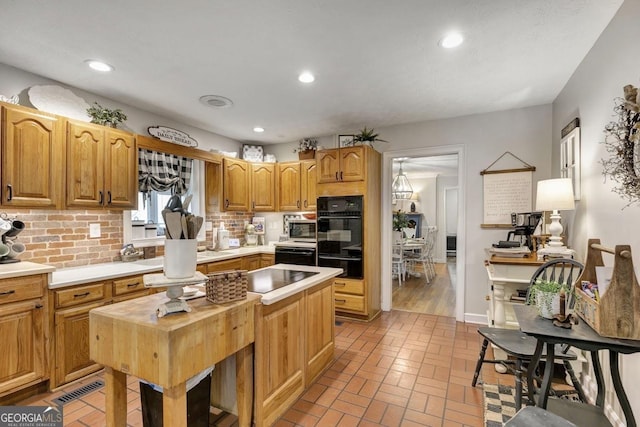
392, 257, 456, 317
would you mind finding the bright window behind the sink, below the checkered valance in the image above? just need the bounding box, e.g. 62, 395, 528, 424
122, 160, 205, 247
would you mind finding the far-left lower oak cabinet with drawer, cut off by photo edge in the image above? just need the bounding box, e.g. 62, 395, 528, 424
0, 274, 48, 405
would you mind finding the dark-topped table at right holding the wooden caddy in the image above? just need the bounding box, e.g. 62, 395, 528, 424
514, 305, 640, 427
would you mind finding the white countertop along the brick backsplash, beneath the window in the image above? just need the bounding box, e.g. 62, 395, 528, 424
50, 245, 275, 289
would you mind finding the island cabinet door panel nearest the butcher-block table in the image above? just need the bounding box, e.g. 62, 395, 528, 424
254, 292, 305, 426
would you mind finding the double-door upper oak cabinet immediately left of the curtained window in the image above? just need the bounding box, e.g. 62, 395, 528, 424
66, 120, 138, 209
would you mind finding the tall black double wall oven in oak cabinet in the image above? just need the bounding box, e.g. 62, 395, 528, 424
317, 196, 364, 279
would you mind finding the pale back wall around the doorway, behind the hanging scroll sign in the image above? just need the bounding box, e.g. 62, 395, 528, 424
376, 105, 551, 322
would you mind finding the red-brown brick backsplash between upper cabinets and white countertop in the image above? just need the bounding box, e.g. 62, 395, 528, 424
2, 209, 253, 268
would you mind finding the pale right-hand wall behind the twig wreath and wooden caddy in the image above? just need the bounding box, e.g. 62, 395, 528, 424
552, 0, 640, 425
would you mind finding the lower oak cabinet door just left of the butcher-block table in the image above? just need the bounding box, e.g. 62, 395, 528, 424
52, 301, 104, 387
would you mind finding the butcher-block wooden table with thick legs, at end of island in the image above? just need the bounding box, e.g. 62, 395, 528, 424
89, 292, 260, 427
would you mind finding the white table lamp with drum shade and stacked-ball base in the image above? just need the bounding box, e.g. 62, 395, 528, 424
536, 178, 575, 249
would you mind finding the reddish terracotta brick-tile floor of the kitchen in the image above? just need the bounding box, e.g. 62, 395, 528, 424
16, 310, 513, 427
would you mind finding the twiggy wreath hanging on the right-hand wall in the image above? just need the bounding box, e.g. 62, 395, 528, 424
600, 85, 640, 209
